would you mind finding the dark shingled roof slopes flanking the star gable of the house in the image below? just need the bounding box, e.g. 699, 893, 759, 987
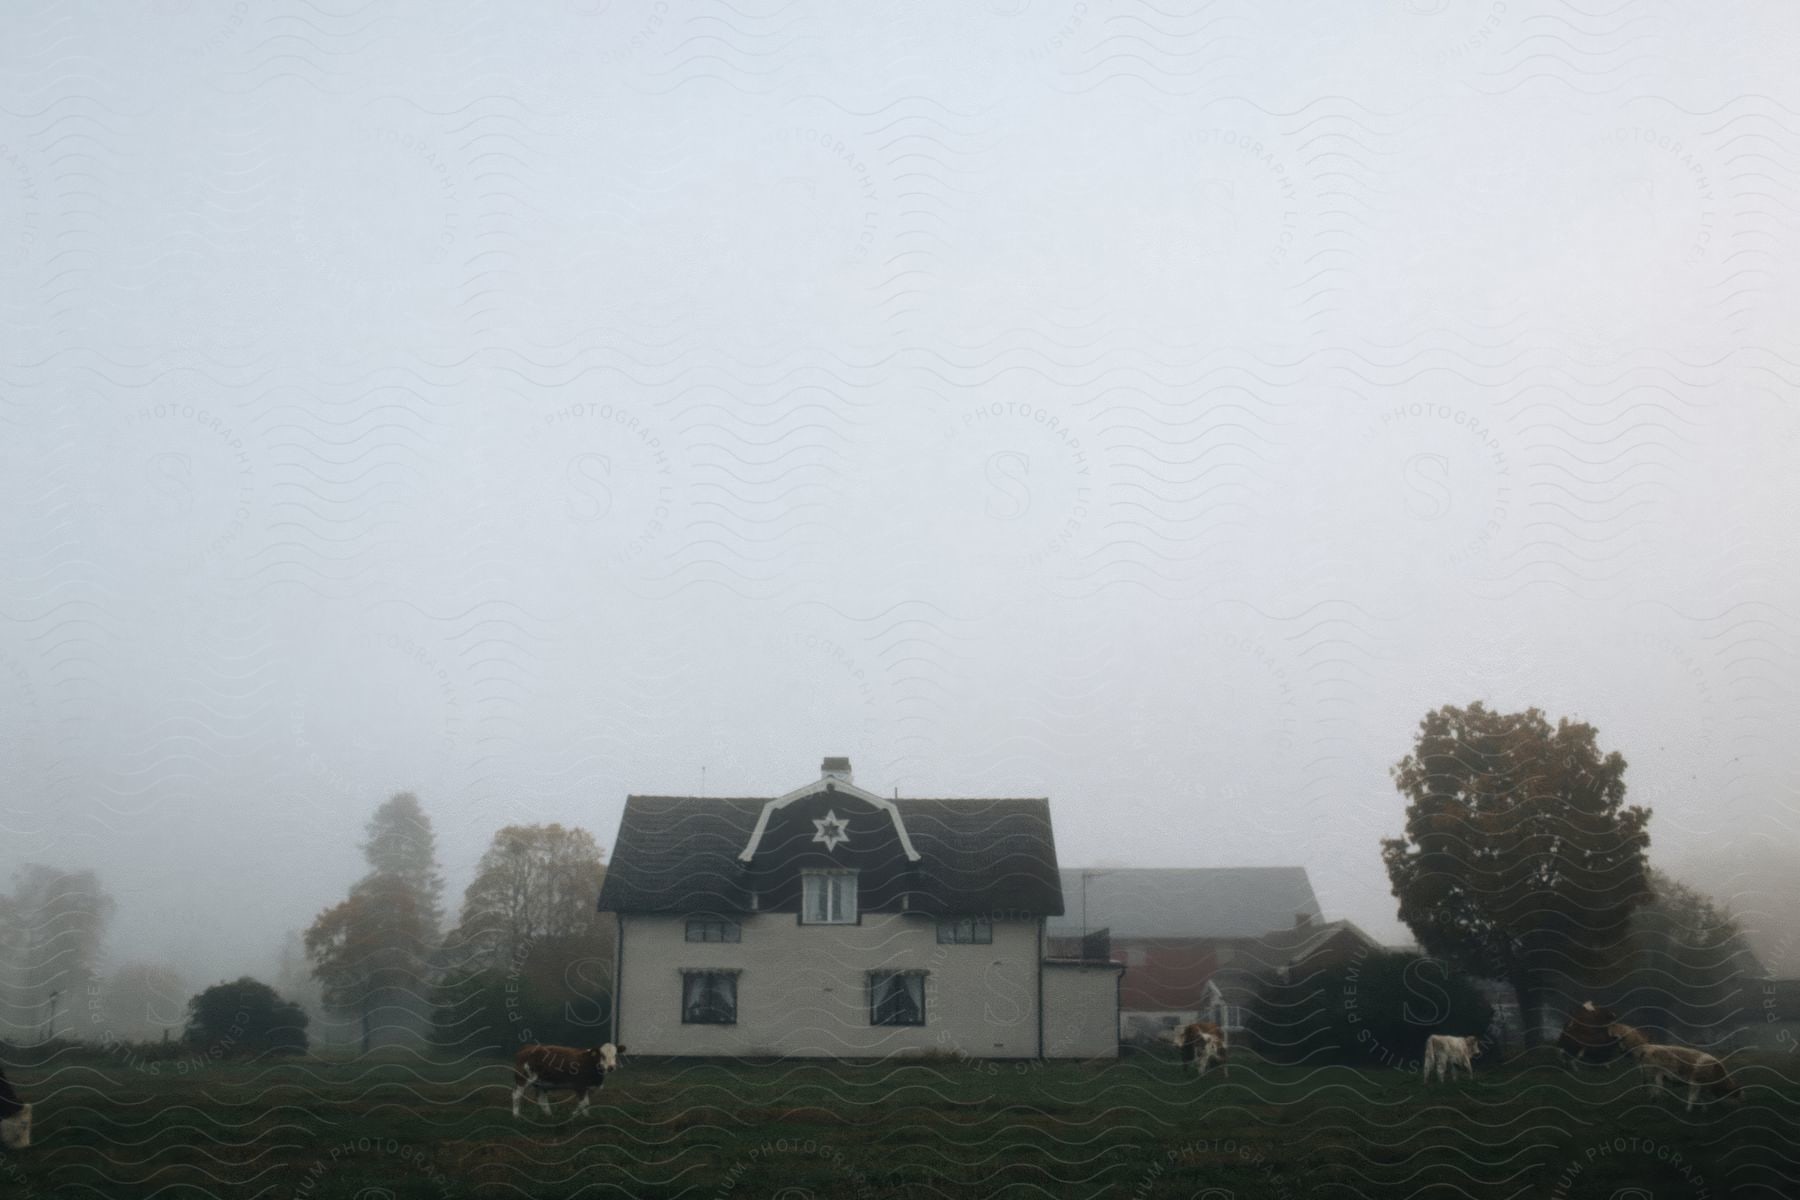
599, 781, 1062, 916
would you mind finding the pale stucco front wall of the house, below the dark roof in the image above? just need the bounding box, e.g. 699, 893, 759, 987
616, 912, 1044, 1058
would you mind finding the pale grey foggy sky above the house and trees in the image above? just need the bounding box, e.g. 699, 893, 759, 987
0, 0, 1800, 984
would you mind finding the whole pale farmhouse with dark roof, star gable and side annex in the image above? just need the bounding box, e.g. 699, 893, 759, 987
599, 757, 1125, 1058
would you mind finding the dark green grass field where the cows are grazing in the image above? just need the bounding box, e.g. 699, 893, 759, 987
0, 1054, 1800, 1200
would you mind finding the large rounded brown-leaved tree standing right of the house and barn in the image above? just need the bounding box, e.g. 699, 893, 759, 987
1381, 702, 1651, 1040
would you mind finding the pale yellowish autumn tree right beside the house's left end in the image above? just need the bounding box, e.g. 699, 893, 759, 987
434, 824, 614, 1047
